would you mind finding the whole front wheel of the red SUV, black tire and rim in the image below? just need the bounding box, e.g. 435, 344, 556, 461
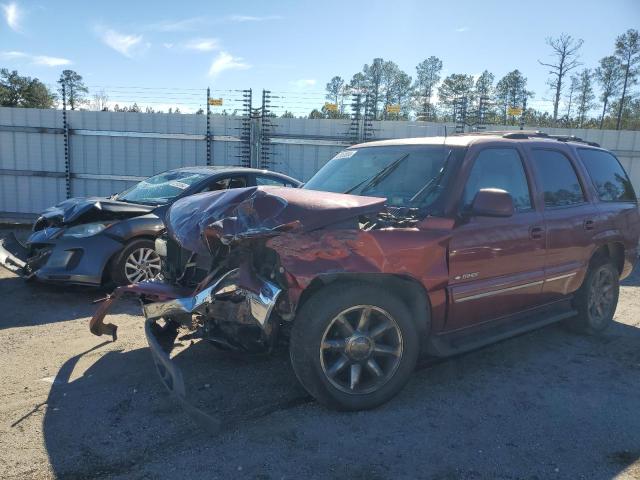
289, 282, 419, 410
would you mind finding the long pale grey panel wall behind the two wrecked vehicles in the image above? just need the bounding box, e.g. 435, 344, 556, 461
0, 108, 640, 216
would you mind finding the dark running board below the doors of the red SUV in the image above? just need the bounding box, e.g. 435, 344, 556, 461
427, 302, 578, 357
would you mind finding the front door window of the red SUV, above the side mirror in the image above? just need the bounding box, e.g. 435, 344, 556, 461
463, 148, 531, 212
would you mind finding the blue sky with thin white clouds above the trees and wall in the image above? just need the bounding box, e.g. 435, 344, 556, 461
0, 0, 640, 114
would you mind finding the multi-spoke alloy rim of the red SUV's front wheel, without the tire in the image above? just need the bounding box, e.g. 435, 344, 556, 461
320, 305, 403, 394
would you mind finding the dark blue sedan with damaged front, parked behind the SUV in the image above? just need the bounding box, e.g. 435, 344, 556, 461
0, 166, 300, 286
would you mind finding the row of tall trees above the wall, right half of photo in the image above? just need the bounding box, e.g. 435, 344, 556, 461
320, 29, 640, 129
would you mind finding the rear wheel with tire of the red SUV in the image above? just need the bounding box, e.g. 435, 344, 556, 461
566, 256, 620, 335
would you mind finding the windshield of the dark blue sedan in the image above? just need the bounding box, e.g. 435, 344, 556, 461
115, 171, 207, 205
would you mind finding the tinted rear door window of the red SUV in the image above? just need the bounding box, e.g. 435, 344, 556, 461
532, 149, 584, 207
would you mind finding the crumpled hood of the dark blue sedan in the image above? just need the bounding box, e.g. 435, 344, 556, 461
41, 197, 156, 224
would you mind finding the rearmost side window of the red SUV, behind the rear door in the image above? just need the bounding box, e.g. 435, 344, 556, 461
578, 148, 636, 202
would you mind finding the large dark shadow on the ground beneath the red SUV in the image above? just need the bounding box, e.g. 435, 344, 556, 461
44, 316, 640, 478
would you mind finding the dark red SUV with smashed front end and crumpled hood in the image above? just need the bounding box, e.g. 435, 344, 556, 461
91, 132, 640, 410
